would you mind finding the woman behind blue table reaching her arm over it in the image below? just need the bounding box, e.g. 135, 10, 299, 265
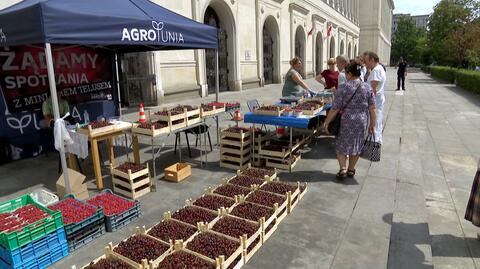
282, 57, 312, 97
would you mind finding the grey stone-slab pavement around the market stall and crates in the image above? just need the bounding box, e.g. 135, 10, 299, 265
0, 69, 480, 269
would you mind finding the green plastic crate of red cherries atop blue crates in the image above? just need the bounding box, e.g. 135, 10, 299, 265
0, 195, 63, 250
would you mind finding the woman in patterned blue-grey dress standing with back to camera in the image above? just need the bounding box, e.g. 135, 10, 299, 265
324, 63, 376, 179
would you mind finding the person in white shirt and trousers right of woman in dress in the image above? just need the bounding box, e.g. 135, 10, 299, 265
363, 51, 387, 143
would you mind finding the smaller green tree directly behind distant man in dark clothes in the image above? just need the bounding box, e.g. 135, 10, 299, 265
391, 16, 417, 62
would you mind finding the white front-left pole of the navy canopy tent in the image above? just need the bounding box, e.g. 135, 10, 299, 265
45, 43, 71, 195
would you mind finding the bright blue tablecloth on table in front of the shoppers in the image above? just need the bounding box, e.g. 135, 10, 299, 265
243, 104, 331, 129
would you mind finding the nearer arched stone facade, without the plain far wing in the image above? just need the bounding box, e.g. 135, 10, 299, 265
141, 0, 360, 103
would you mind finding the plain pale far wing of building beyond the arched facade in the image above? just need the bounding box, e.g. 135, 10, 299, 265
359, 0, 395, 63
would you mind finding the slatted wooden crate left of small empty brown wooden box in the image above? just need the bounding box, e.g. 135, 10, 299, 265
110, 163, 152, 200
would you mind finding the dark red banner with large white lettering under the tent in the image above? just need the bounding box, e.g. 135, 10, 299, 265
0, 46, 113, 112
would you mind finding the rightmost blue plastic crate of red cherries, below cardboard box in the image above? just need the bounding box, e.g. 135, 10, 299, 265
87, 190, 141, 232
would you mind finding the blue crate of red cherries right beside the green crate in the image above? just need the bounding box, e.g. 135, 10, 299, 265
48, 195, 104, 236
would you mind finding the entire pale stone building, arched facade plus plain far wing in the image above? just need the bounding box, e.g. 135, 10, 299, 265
0, 0, 393, 105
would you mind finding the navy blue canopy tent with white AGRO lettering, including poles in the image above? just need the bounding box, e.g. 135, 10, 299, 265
0, 0, 219, 193
